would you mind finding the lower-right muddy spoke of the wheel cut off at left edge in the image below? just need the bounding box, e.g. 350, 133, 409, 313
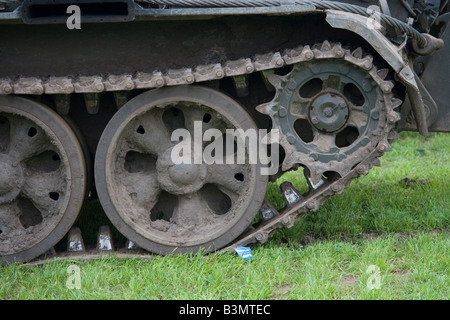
22, 169, 66, 217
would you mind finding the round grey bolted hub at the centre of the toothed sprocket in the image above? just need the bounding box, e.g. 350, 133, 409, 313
309, 92, 349, 132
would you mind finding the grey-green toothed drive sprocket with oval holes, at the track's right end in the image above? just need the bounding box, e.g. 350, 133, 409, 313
257, 41, 401, 188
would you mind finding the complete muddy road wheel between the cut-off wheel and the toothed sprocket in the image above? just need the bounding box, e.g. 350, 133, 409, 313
95, 86, 267, 254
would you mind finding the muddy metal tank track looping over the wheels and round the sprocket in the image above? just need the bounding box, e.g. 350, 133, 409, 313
6, 41, 401, 264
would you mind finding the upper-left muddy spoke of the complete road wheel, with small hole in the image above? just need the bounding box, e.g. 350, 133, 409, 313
126, 111, 171, 155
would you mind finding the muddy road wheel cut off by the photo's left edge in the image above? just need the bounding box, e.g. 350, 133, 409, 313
0, 97, 86, 263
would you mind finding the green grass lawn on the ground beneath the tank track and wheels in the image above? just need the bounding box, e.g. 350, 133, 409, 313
0, 133, 450, 300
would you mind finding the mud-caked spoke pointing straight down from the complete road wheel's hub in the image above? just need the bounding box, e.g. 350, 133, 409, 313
172, 192, 214, 228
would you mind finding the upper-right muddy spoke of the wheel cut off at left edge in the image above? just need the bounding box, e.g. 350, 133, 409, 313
8, 116, 56, 161
